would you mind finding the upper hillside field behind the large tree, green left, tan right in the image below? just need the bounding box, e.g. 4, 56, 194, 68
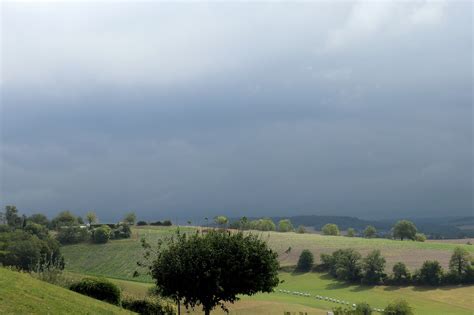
62, 227, 474, 281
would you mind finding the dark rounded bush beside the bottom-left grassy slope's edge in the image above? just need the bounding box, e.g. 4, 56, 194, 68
69, 278, 122, 305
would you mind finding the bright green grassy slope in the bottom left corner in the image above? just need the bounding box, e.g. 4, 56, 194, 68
0, 268, 132, 314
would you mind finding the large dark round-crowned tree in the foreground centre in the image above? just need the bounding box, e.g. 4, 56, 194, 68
145, 231, 279, 315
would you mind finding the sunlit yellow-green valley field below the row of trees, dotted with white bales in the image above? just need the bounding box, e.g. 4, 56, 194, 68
76, 272, 474, 315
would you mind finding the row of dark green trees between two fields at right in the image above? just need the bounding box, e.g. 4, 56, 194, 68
297, 247, 474, 285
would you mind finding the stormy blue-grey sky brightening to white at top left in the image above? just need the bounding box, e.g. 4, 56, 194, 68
0, 1, 474, 221
